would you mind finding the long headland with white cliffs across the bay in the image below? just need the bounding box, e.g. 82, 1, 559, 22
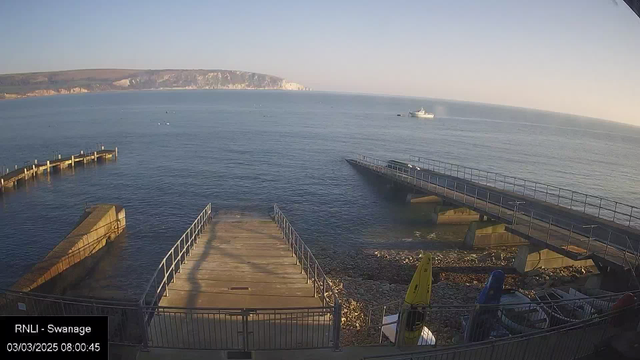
0, 69, 310, 99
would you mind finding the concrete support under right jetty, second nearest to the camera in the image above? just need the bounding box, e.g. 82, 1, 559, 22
464, 221, 529, 249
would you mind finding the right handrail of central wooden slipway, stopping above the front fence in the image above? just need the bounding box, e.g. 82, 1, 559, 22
273, 204, 340, 306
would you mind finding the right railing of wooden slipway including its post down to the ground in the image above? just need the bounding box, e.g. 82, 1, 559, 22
273, 204, 342, 349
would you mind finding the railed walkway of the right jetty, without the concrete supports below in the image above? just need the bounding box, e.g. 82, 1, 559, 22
354, 155, 640, 283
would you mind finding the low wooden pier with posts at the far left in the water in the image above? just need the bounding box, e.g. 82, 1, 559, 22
0, 146, 118, 191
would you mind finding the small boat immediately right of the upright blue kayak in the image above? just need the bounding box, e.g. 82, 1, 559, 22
498, 291, 549, 335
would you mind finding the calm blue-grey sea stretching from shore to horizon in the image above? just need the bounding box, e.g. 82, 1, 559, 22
0, 90, 640, 297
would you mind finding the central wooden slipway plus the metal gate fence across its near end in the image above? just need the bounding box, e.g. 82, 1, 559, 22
148, 215, 333, 350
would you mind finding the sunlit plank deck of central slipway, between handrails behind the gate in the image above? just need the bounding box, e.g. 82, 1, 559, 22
160, 215, 322, 308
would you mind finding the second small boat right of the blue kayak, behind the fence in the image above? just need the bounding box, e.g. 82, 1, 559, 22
535, 289, 596, 326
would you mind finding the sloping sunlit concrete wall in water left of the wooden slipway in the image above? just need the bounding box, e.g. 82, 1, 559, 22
11, 204, 125, 291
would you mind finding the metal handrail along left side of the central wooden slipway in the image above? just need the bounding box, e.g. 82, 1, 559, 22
140, 203, 212, 306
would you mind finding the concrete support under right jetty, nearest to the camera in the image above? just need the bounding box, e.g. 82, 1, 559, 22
513, 245, 593, 273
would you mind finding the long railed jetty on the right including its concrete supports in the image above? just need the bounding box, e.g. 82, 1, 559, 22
347, 155, 640, 287
